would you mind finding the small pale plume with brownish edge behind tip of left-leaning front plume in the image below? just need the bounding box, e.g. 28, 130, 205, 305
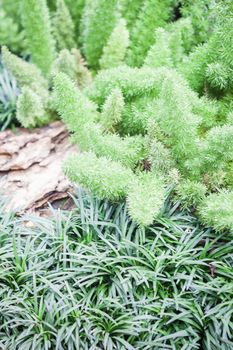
51, 48, 92, 89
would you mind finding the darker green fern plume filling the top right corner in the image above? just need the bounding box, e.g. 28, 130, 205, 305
182, 1, 233, 95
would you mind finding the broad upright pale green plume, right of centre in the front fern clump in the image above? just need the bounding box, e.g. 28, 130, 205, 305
153, 72, 200, 167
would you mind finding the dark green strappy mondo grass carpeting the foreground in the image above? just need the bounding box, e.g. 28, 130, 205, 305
0, 191, 233, 350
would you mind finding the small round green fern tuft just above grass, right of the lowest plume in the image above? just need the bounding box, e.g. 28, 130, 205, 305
176, 180, 207, 208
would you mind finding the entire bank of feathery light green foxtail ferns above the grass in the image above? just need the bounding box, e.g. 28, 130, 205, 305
2, 0, 233, 230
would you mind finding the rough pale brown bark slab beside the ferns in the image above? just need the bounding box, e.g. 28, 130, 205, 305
0, 122, 76, 213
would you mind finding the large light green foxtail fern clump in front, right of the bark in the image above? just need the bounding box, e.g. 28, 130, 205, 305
55, 56, 232, 225
